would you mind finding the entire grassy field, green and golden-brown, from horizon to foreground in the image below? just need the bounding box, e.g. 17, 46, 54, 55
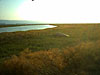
0, 24, 100, 75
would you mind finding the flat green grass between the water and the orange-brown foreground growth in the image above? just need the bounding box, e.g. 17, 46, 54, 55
0, 25, 100, 59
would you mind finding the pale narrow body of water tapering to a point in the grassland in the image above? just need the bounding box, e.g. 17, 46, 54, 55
0, 25, 56, 33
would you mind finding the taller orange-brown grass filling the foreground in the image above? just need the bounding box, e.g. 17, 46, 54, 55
0, 40, 100, 75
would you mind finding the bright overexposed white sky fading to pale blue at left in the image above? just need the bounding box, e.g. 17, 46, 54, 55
0, 0, 100, 23
